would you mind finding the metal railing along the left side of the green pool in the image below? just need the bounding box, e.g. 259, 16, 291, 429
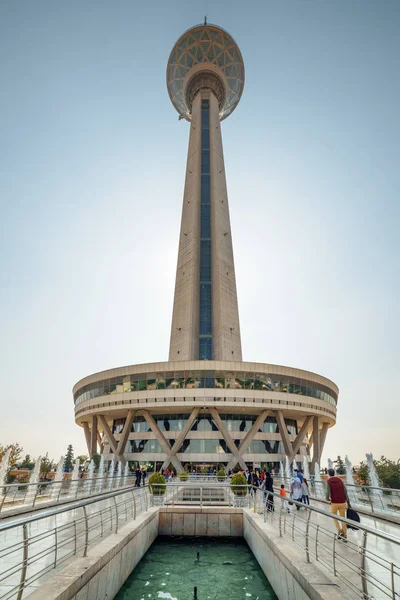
0, 487, 151, 600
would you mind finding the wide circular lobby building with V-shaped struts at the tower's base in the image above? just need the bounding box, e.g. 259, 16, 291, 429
73, 360, 338, 472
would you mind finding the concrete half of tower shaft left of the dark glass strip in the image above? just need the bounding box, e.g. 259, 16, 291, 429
169, 95, 201, 361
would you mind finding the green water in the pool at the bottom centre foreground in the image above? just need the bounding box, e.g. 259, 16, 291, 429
115, 537, 277, 600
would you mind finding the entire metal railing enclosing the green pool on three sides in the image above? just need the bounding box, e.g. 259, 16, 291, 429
0, 481, 400, 600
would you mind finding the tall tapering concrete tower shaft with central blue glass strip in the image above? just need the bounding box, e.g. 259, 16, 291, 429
169, 88, 242, 361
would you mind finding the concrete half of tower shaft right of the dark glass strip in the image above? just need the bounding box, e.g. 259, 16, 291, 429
209, 92, 242, 361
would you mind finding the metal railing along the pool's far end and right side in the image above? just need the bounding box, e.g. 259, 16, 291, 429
148, 481, 400, 600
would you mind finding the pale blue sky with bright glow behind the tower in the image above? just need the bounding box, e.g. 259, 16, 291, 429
0, 0, 400, 463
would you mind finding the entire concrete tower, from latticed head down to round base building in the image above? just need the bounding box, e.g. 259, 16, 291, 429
73, 23, 338, 472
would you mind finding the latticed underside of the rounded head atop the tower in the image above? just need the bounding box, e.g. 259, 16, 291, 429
167, 25, 244, 120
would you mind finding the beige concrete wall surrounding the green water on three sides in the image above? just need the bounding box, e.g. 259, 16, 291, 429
29, 507, 348, 600
